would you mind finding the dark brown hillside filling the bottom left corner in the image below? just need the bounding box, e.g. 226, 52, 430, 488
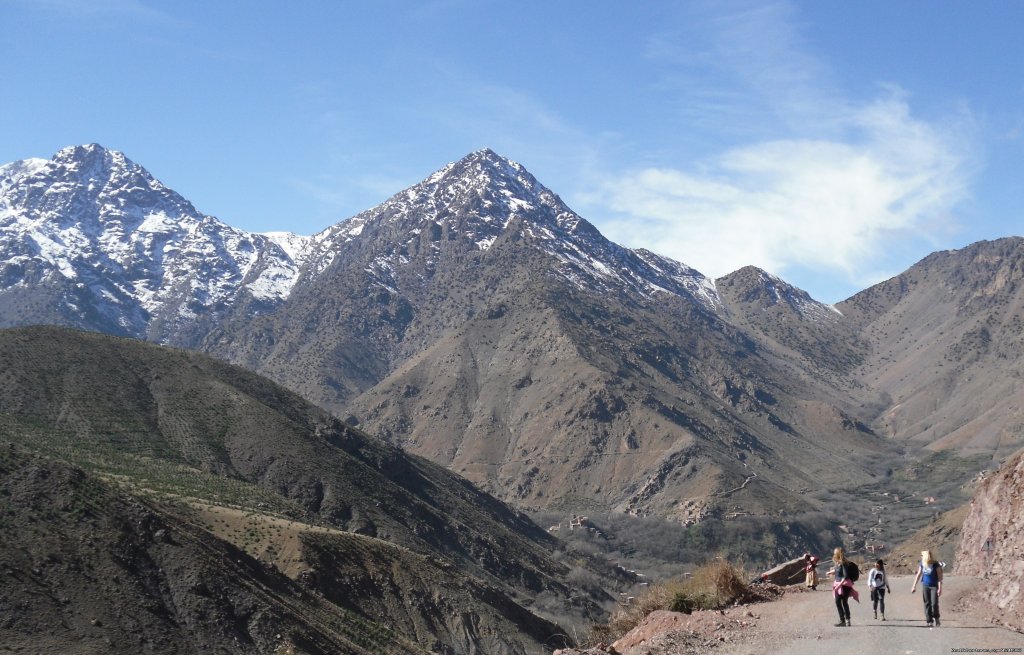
0, 444, 426, 655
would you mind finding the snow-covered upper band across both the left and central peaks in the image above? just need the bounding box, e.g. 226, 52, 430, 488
0, 143, 814, 342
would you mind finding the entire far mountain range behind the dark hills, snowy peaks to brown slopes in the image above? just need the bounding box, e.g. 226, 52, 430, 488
0, 145, 1024, 523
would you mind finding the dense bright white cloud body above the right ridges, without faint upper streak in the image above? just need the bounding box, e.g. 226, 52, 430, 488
588, 91, 967, 279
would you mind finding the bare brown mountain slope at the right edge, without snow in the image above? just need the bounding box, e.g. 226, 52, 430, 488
838, 237, 1024, 462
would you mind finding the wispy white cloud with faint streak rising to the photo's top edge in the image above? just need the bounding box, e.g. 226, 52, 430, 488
584, 4, 971, 294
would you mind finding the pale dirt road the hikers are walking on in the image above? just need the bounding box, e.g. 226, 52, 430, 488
714, 576, 1024, 655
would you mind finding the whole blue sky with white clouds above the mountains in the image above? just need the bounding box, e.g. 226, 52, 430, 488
0, 0, 1024, 302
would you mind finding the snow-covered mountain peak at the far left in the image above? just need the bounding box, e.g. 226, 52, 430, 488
0, 143, 311, 339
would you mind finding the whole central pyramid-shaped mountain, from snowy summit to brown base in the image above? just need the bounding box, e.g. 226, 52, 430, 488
193, 150, 888, 520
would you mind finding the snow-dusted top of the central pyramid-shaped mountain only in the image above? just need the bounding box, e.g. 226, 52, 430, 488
303, 148, 721, 310
